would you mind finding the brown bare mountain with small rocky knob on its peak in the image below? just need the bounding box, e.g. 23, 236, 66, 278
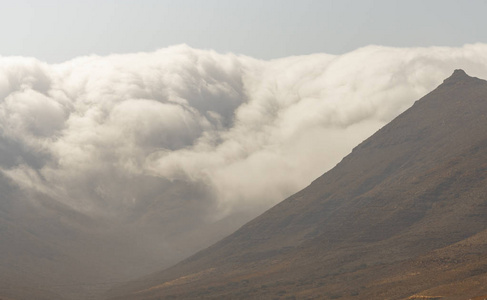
109, 70, 487, 299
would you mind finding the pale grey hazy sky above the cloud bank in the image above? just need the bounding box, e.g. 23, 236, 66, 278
0, 0, 487, 63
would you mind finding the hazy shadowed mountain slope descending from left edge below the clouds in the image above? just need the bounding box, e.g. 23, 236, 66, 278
0, 171, 182, 300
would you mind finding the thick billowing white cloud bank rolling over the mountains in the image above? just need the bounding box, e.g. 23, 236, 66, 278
0, 44, 487, 264
